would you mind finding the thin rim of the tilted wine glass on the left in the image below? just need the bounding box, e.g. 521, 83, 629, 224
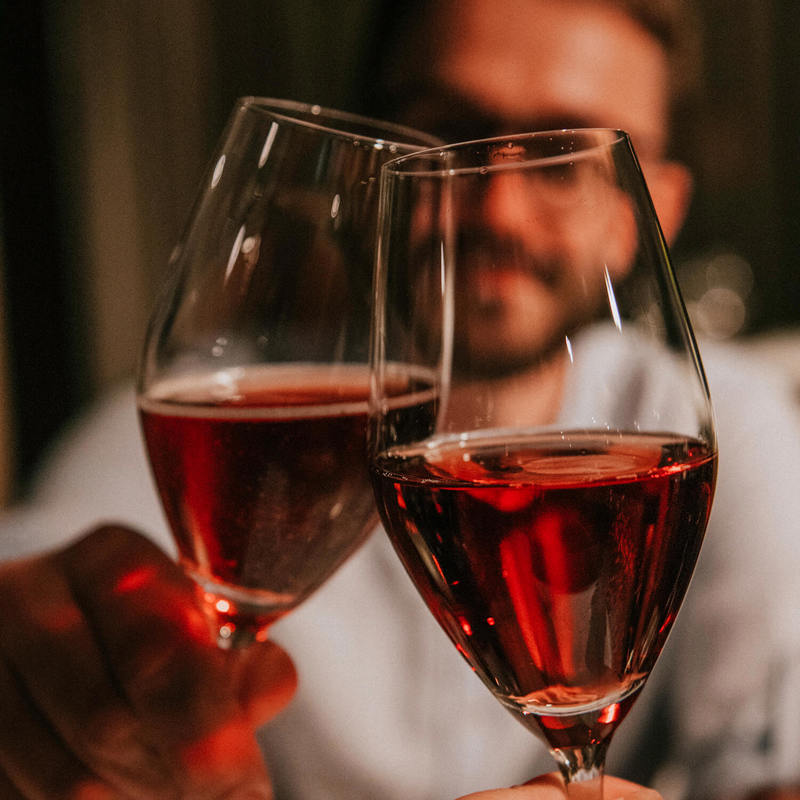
236, 95, 442, 157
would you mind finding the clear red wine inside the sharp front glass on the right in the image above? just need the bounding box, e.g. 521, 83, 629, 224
373, 432, 716, 747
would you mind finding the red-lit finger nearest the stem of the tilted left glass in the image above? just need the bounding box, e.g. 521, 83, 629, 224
58, 527, 269, 800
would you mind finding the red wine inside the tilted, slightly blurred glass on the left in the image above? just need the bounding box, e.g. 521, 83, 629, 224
140, 365, 377, 635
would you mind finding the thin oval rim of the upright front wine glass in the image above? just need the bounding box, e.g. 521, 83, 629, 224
382, 128, 632, 178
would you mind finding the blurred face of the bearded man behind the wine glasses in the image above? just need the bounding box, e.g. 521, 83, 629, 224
390, 0, 668, 369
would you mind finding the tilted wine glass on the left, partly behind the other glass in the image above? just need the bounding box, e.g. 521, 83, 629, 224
138, 98, 436, 647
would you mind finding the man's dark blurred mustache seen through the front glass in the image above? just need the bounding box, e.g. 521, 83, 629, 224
411, 227, 565, 287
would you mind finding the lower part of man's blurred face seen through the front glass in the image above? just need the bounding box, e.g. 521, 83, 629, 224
412, 138, 636, 377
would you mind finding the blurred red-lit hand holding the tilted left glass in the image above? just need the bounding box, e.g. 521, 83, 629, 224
0, 527, 296, 800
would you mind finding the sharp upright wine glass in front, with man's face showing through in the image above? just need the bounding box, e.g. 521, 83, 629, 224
368, 130, 717, 798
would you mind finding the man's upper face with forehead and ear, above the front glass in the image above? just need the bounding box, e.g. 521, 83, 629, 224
396, 0, 692, 234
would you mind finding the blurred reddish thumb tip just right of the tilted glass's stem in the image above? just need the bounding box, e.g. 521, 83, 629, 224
238, 642, 297, 728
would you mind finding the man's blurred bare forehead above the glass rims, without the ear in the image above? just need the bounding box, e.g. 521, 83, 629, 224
422, 0, 667, 155
